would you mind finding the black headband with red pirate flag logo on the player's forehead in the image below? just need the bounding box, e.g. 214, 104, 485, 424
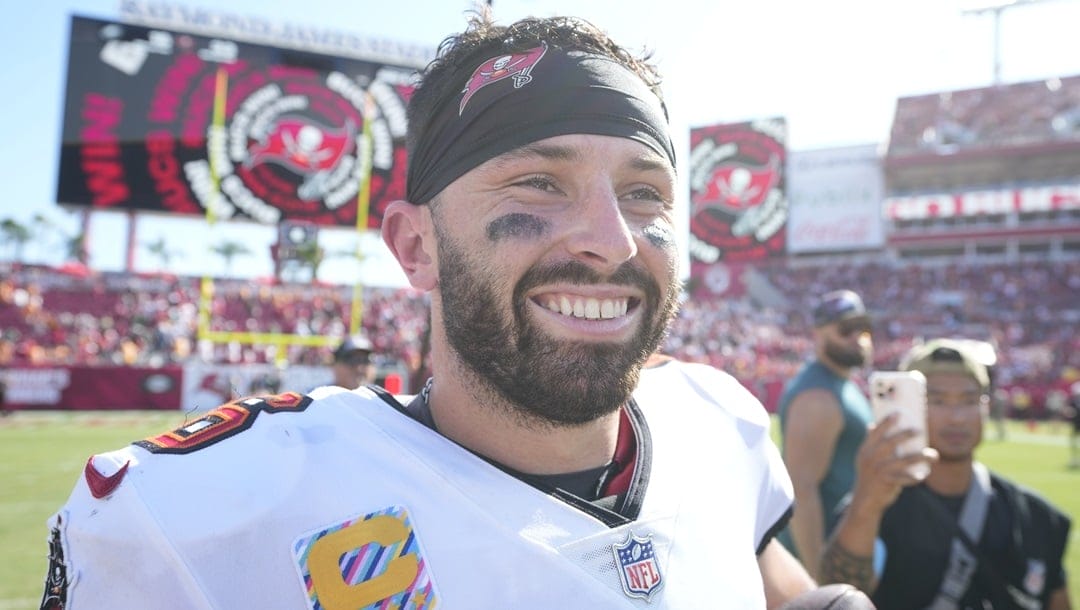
406, 44, 675, 204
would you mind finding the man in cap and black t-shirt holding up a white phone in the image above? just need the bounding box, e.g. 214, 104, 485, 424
822, 339, 1070, 610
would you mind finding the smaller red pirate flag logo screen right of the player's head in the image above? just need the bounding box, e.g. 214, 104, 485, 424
689, 119, 787, 264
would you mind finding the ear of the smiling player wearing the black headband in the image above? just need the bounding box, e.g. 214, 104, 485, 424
382, 201, 438, 290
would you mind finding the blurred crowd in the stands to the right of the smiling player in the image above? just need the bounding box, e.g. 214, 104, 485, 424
669, 260, 1080, 411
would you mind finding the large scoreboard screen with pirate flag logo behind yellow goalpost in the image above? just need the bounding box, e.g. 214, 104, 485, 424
57, 17, 415, 228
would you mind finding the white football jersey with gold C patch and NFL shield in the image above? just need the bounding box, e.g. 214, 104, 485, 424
43, 362, 793, 610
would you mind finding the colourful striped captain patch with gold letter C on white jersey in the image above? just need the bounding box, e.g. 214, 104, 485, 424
293, 506, 438, 610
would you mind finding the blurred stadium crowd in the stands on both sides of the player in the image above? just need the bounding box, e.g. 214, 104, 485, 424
0, 260, 1080, 414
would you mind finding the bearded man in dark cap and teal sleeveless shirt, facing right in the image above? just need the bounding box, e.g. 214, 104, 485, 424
778, 289, 874, 577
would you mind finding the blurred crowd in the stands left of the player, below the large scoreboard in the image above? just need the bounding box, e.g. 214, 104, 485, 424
0, 266, 428, 373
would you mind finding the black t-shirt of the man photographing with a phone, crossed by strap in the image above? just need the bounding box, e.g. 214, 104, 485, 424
873, 474, 1069, 610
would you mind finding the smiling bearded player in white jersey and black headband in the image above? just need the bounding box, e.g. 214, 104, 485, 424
39, 10, 861, 610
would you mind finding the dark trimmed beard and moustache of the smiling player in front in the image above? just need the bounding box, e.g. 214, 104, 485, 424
436, 234, 678, 425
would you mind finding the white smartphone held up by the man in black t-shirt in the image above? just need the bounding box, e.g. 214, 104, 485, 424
868, 370, 930, 480
